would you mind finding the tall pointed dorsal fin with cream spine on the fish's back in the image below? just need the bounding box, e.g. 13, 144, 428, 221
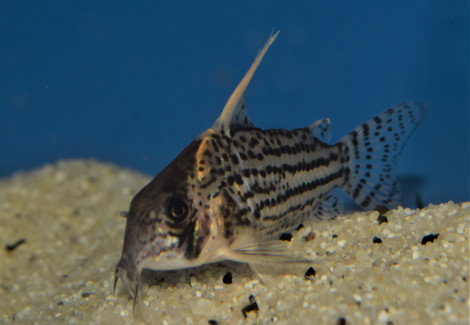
212, 31, 279, 136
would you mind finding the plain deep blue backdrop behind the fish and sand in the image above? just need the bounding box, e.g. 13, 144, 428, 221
0, 0, 470, 203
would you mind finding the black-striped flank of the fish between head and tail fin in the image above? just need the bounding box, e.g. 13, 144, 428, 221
197, 128, 344, 235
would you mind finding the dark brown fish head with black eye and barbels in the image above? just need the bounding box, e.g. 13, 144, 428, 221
115, 139, 217, 298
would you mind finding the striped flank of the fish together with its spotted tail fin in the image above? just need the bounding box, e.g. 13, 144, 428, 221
191, 103, 423, 240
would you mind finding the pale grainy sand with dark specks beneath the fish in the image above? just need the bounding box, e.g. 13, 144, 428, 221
0, 161, 470, 324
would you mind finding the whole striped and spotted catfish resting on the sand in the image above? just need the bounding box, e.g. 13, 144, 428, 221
116, 34, 424, 297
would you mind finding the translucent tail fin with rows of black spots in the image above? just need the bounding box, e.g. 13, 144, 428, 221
340, 102, 425, 210
